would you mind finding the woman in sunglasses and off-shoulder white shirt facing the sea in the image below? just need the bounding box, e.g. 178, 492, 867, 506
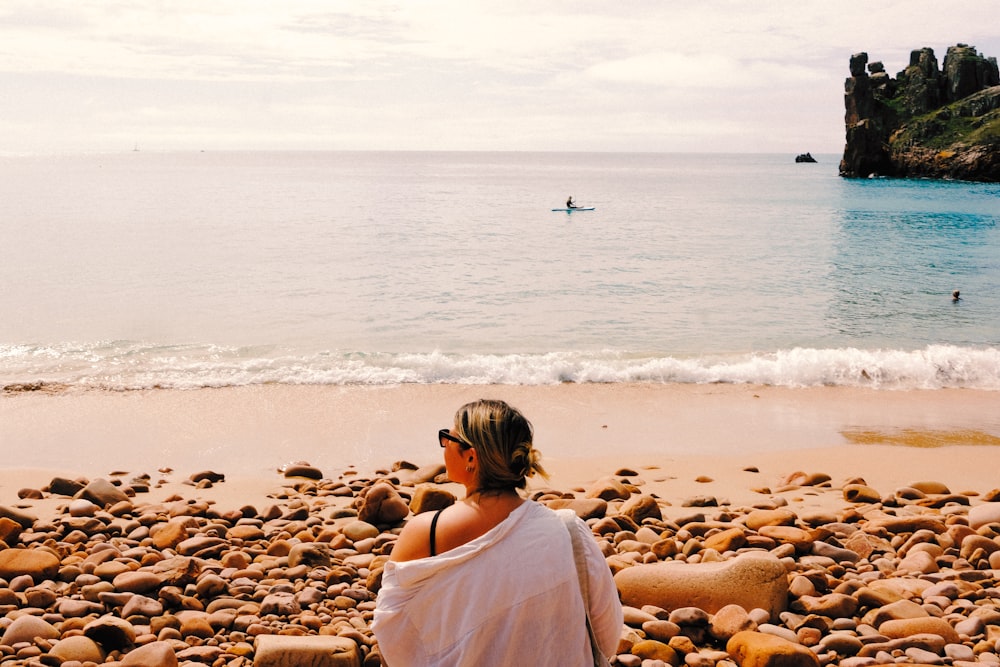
372, 400, 622, 667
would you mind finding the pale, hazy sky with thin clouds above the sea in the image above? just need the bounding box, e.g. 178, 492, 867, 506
0, 0, 1000, 154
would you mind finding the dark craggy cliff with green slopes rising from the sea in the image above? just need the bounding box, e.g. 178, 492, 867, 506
840, 44, 1000, 182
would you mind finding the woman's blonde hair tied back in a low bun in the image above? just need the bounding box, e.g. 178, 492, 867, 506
455, 399, 547, 492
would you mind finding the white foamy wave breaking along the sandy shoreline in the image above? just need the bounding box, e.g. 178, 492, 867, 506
0, 341, 1000, 390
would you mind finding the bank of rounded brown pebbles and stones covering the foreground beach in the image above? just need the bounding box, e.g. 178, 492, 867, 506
0, 462, 1000, 667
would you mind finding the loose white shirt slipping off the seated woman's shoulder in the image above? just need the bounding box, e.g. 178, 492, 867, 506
372, 501, 621, 667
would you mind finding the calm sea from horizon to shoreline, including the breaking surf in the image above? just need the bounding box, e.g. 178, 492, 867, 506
0, 151, 1000, 390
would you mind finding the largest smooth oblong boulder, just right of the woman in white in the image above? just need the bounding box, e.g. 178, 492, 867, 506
615, 552, 788, 618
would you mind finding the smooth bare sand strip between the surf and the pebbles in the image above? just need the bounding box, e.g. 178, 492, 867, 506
0, 384, 1000, 511
